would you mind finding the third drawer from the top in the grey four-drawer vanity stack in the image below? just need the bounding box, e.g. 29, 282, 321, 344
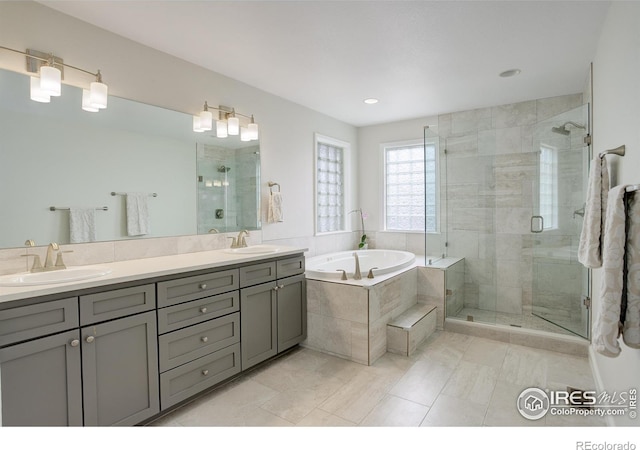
158, 313, 240, 372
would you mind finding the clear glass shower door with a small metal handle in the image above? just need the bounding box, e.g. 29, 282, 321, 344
531, 105, 590, 338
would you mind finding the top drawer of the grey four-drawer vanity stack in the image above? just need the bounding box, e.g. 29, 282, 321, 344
158, 269, 239, 308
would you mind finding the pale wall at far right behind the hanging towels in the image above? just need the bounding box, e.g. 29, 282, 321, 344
591, 2, 640, 426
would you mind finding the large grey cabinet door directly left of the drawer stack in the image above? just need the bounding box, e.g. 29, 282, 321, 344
81, 311, 160, 426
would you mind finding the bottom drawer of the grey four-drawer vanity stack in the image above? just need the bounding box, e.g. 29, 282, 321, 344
160, 344, 240, 409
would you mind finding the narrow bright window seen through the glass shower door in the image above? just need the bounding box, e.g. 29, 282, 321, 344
539, 145, 558, 230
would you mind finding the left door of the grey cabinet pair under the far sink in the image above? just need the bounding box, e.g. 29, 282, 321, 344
240, 282, 278, 370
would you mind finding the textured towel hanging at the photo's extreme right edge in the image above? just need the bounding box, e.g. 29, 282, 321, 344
622, 192, 640, 348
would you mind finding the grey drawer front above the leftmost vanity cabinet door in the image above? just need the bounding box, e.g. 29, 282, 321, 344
0, 297, 78, 346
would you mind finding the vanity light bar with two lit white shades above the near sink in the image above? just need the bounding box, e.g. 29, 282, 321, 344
0, 46, 108, 112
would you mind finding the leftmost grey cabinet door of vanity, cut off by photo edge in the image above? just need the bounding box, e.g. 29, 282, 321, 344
0, 329, 82, 427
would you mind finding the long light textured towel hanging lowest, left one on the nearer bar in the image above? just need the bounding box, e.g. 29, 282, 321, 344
593, 186, 626, 356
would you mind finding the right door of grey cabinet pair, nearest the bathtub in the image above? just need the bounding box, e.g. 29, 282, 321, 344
277, 275, 307, 352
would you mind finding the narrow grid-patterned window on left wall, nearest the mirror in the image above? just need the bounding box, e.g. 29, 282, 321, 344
316, 135, 350, 234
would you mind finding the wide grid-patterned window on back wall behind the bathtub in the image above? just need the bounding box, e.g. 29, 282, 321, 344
383, 141, 438, 233
